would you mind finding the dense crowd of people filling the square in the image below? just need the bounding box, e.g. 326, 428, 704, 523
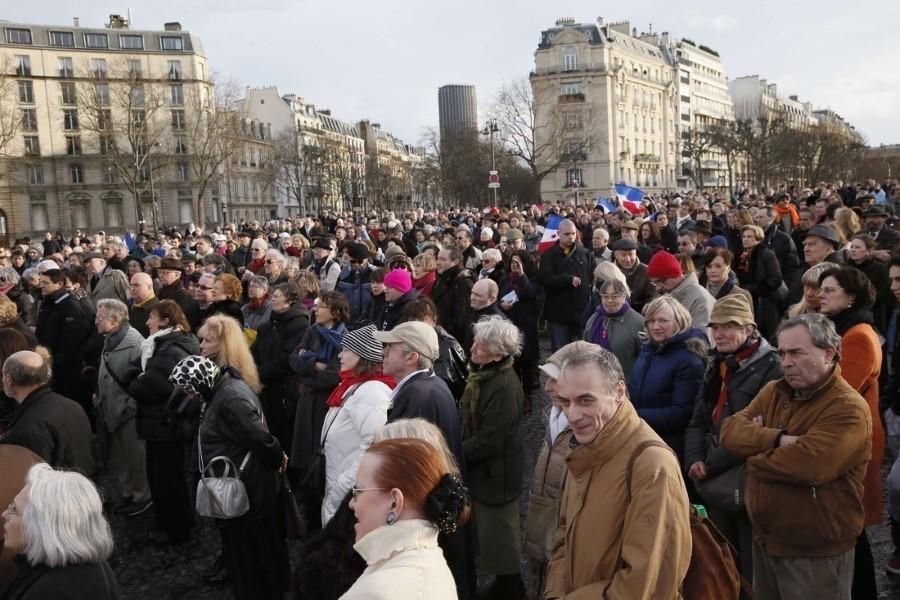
0, 182, 900, 600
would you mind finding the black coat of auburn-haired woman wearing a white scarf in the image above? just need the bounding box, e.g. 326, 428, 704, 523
123, 330, 200, 442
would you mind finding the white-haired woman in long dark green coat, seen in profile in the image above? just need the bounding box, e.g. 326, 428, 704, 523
460, 316, 525, 598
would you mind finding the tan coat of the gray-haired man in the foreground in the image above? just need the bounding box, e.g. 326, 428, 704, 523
544, 401, 691, 600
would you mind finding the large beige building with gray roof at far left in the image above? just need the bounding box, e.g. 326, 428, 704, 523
0, 15, 213, 235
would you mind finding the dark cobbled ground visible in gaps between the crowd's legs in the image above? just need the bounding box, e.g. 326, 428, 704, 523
102, 340, 900, 600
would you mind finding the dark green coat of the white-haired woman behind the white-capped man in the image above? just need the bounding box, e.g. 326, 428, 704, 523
461, 361, 525, 505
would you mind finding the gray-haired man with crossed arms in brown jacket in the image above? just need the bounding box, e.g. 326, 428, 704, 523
721, 314, 872, 600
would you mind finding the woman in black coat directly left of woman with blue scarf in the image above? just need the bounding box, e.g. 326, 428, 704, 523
250, 282, 309, 448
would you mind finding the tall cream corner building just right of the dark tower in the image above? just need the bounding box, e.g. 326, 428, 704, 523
531, 18, 680, 201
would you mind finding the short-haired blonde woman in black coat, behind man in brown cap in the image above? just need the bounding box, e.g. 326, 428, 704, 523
734, 225, 787, 339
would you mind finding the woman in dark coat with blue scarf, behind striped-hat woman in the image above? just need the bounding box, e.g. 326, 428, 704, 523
290, 292, 350, 531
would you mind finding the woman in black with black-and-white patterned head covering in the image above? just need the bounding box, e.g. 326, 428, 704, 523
171, 356, 290, 599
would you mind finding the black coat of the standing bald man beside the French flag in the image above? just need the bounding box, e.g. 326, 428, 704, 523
540, 243, 594, 325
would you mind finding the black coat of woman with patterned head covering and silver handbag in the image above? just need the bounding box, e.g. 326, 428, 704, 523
197, 369, 283, 523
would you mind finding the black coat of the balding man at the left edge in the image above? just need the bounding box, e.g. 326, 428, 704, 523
0, 385, 94, 475
